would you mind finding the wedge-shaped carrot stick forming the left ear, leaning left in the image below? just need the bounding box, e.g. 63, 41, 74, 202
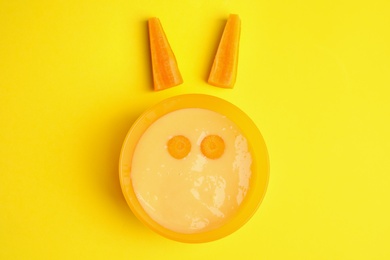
148, 17, 183, 90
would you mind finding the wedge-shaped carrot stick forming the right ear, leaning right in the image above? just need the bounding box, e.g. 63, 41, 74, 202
208, 14, 241, 88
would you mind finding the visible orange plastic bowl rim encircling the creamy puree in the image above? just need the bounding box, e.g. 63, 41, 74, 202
119, 94, 269, 243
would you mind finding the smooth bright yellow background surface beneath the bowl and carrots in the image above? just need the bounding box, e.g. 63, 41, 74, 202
0, 0, 390, 259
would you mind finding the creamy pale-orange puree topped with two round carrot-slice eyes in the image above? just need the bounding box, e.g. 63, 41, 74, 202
131, 108, 252, 234
